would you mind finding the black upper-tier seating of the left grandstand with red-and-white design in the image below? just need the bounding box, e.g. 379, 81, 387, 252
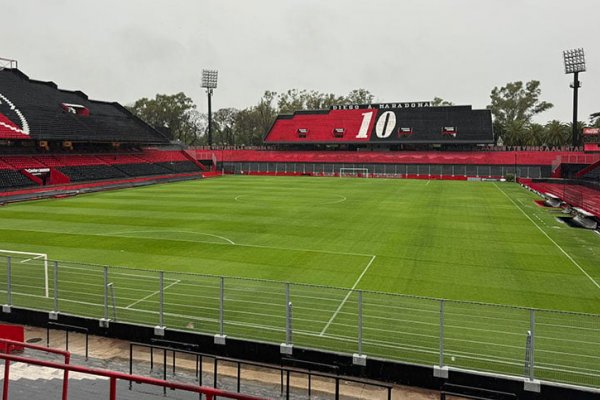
0, 69, 169, 144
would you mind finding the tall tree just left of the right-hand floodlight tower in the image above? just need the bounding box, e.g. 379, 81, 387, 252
488, 80, 554, 130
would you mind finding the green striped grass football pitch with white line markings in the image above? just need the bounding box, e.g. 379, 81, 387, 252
0, 176, 600, 386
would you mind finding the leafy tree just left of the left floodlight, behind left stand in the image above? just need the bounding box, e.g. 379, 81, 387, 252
127, 92, 196, 143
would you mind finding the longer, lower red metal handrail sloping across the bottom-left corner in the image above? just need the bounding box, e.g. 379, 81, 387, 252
0, 343, 266, 400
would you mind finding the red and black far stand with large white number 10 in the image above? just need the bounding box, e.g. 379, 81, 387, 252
264, 102, 494, 149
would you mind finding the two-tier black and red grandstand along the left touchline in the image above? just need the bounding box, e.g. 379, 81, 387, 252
0, 68, 205, 199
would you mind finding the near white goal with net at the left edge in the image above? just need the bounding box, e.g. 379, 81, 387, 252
0, 249, 49, 297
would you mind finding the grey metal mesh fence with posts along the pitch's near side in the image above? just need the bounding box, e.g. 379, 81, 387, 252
0, 255, 600, 388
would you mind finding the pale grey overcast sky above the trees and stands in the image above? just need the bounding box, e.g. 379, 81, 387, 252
0, 0, 600, 122
